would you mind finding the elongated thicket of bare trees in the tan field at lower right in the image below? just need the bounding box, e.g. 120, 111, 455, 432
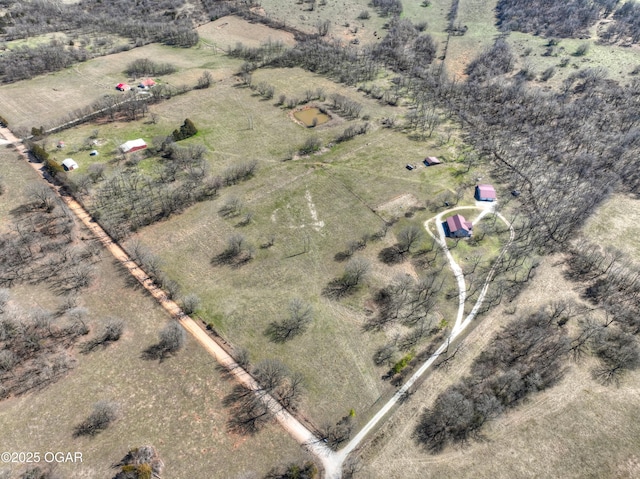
414, 310, 570, 453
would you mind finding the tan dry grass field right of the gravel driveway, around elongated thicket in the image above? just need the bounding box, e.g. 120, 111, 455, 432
357, 257, 640, 479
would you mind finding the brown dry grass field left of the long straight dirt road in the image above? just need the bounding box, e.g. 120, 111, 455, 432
0, 156, 305, 478
